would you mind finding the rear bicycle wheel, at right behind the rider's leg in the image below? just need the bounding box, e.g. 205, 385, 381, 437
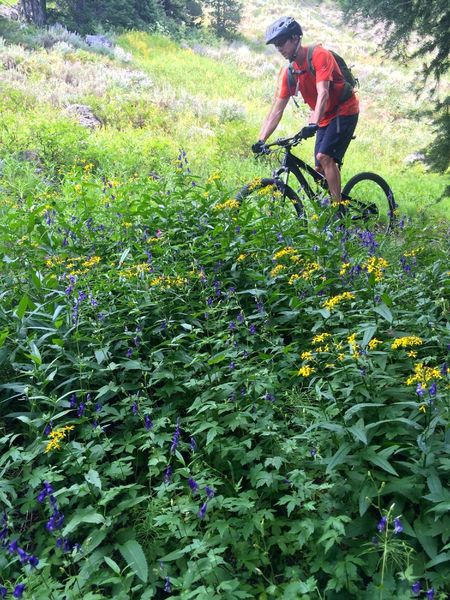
342, 173, 397, 232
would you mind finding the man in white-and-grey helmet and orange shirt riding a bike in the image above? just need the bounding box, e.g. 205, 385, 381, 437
252, 17, 359, 202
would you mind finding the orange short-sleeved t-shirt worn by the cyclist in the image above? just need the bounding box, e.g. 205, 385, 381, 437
277, 45, 359, 127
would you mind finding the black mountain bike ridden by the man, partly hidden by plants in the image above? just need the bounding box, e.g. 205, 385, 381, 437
235, 133, 397, 232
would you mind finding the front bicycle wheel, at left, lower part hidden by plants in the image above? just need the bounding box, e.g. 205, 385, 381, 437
235, 178, 304, 218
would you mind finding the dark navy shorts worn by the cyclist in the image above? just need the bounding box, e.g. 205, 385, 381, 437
314, 115, 358, 166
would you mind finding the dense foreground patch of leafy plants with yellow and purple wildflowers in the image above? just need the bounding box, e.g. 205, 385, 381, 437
0, 151, 450, 600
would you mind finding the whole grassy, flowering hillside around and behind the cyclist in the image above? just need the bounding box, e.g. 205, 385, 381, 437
0, 0, 450, 600
